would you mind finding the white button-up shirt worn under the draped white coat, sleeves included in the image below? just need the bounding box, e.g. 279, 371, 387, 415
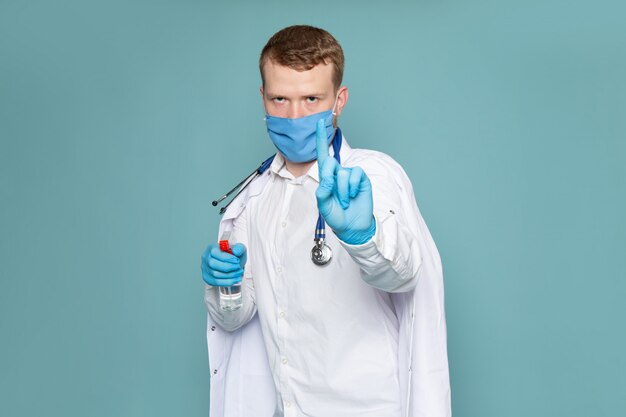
207, 138, 442, 417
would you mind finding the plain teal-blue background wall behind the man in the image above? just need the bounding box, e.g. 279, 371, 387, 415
0, 0, 626, 417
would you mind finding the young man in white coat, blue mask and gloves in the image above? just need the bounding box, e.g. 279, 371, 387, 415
202, 26, 450, 417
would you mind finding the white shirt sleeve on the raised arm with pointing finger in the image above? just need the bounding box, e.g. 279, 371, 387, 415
340, 155, 423, 292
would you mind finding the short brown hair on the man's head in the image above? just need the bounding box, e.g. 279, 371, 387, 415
259, 25, 344, 90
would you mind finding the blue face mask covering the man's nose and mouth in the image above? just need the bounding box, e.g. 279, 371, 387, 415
265, 95, 337, 163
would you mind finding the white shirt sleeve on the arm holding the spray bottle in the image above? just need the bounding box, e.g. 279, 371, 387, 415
204, 206, 257, 331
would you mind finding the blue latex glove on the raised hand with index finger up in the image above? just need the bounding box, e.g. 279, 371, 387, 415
315, 119, 376, 245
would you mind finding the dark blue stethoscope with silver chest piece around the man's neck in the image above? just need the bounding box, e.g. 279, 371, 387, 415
212, 128, 343, 266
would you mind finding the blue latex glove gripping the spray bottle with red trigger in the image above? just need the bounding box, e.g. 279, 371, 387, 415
202, 243, 248, 287
